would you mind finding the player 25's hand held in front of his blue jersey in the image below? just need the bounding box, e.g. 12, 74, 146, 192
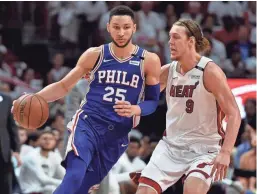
113, 101, 137, 117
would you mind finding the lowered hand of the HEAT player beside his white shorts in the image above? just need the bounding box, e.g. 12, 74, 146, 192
211, 152, 230, 181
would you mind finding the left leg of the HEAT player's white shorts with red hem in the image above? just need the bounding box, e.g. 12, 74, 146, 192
139, 140, 188, 193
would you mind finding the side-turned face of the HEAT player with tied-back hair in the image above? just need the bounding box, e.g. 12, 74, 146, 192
169, 25, 192, 60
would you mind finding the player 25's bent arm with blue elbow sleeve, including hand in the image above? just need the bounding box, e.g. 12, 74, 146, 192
114, 52, 161, 117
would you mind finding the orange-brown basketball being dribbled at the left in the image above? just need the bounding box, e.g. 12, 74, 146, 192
13, 94, 49, 129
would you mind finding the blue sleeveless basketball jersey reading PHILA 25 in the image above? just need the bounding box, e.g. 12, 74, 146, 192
81, 43, 145, 131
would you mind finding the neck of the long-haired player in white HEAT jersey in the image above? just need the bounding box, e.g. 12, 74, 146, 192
178, 53, 201, 74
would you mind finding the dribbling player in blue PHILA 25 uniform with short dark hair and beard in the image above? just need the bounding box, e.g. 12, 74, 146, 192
12, 6, 161, 194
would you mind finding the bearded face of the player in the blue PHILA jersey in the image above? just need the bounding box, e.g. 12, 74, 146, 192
107, 15, 136, 48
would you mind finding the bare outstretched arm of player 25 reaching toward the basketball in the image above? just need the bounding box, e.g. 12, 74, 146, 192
37, 47, 101, 102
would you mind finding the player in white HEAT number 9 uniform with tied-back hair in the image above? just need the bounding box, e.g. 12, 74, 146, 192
135, 20, 241, 194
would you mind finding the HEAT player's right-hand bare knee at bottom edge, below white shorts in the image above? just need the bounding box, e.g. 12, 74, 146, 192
183, 177, 209, 194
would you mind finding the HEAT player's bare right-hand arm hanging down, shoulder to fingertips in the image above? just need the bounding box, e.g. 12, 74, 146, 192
204, 62, 241, 180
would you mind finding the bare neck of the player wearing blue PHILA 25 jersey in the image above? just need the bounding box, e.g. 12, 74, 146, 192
111, 43, 136, 59
